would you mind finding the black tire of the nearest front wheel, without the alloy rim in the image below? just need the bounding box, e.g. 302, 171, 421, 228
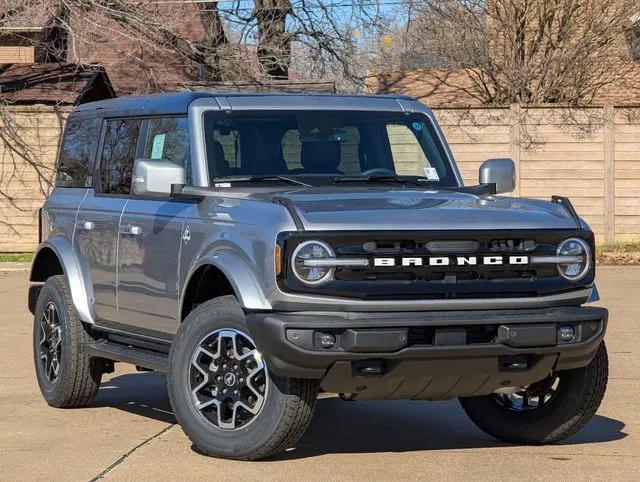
167, 296, 318, 460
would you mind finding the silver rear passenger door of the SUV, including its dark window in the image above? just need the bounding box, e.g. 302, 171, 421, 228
74, 119, 142, 326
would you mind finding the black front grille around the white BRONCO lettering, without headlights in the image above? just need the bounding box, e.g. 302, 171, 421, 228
279, 230, 593, 300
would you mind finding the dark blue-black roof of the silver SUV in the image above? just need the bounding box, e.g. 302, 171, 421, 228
76, 92, 414, 115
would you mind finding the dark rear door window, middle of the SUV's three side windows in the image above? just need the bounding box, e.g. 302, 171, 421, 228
100, 119, 142, 194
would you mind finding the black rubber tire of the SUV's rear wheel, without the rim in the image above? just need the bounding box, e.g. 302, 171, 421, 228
33, 275, 102, 408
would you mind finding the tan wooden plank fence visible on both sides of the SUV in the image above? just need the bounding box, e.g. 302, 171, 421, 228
0, 102, 640, 252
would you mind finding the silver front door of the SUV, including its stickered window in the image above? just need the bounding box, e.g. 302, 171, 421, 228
118, 117, 192, 338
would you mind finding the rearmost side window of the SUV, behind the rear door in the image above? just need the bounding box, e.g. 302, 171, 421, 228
56, 119, 100, 187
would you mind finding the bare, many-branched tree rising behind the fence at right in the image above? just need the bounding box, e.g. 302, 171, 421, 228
380, 0, 639, 105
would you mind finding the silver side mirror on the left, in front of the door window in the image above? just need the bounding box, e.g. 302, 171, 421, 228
132, 159, 186, 197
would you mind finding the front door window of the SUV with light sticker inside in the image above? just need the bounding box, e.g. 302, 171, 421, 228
144, 117, 191, 184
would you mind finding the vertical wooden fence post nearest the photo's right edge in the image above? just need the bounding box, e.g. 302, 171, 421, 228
603, 104, 616, 244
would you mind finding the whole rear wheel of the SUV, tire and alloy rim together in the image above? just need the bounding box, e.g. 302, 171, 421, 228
33, 276, 102, 408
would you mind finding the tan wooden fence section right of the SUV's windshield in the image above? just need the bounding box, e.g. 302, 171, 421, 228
436, 105, 640, 244
